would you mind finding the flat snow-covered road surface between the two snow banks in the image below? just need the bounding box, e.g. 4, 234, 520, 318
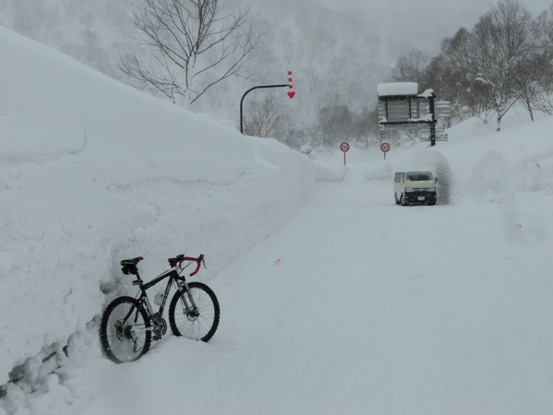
54, 166, 553, 415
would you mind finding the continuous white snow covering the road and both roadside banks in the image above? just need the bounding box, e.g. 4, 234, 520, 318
0, 24, 553, 415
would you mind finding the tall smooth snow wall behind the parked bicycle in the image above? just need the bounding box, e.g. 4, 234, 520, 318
0, 28, 317, 384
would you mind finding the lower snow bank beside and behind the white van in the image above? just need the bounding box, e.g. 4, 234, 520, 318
378, 113, 553, 204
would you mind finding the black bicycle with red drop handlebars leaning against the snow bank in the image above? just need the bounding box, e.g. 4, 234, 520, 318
100, 254, 220, 363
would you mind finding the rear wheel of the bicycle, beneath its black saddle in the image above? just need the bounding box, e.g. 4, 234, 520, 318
100, 297, 152, 363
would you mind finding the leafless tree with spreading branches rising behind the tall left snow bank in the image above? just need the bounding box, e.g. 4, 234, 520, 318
120, 0, 260, 107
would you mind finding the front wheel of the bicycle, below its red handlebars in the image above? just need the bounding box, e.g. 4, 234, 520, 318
169, 282, 220, 342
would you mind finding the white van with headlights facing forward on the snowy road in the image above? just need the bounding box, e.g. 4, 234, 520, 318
394, 171, 438, 206
